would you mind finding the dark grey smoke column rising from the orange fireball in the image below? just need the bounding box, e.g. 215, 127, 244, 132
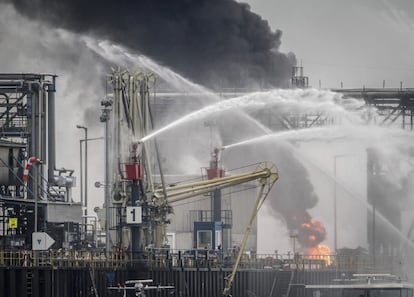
217, 111, 327, 249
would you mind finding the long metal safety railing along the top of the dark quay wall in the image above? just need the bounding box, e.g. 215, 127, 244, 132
0, 249, 402, 273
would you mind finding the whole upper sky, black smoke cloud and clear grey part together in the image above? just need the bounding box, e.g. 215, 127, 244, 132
7, 0, 414, 88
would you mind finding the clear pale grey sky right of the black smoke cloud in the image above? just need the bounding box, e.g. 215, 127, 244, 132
241, 0, 414, 88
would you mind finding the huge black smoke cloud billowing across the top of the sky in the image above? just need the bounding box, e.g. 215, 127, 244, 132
9, 0, 295, 87
